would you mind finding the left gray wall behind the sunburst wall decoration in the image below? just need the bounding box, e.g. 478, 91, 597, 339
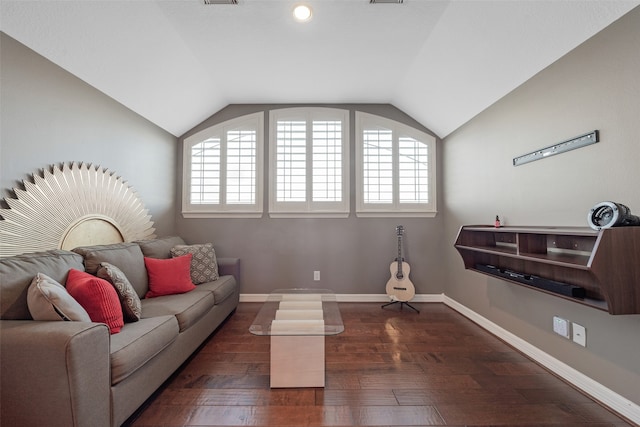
0, 33, 177, 234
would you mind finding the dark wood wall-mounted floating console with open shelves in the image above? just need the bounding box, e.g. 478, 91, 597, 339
455, 225, 640, 314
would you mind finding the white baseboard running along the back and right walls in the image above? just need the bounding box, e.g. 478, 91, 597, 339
240, 294, 640, 425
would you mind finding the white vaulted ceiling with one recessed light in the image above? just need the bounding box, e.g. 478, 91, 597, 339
0, 0, 640, 137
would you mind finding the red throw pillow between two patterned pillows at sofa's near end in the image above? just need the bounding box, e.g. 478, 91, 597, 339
66, 268, 124, 334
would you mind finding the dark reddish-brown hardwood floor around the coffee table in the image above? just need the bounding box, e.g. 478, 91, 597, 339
129, 303, 630, 427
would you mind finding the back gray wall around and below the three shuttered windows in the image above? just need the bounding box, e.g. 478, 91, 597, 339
177, 105, 444, 294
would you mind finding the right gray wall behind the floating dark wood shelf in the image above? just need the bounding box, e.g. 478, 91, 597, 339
443, 8, 640, 404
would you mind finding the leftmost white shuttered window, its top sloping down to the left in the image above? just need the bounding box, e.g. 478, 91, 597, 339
182, 113, 264, 218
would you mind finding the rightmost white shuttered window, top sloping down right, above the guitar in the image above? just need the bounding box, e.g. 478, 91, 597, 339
356, 112, 436, 216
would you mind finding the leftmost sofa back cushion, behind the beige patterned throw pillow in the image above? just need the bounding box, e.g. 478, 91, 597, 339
0, 249, 84, 320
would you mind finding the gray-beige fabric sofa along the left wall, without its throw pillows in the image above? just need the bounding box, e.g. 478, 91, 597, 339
0, 237, 240, 427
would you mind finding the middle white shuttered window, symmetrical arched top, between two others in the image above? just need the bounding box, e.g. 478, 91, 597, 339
270, 108, 349, 216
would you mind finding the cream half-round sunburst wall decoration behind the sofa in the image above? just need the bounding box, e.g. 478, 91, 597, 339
0, 162, 155, 257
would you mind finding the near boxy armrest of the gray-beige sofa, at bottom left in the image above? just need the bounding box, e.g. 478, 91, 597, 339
0, 320, 111, 426
